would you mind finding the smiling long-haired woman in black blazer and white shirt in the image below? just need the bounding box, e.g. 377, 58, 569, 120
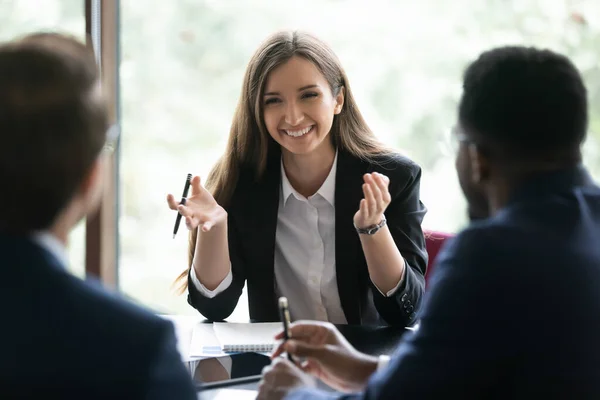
168, 31, 427, 326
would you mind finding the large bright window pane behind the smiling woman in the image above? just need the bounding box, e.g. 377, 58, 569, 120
115, 0, 600, 320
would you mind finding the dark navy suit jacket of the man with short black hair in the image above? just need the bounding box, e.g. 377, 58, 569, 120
290, 168, 600, 399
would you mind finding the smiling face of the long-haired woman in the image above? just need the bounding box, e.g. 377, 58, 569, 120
262, 56, 344, 158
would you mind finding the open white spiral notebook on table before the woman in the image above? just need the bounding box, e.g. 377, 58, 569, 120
213, 322, 283, 353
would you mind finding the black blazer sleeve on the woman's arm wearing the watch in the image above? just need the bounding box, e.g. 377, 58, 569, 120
371, 160, 427, 326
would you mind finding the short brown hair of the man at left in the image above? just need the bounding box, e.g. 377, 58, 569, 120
0, 33, 108, 233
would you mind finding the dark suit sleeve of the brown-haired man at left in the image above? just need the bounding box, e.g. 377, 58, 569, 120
145, 322, 196, 400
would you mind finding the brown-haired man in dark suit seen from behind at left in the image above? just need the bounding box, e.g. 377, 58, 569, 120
0, 33, 196, 399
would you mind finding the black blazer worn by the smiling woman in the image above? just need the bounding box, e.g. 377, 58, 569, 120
188, 151, 427, 326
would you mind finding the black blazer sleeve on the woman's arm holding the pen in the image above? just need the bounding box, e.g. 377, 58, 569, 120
188, 212, 246, 321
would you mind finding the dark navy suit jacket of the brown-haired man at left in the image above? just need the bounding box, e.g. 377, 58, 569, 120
0, 234, 196, 399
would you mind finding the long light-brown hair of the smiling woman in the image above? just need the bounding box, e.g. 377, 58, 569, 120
176, 31, 390, 293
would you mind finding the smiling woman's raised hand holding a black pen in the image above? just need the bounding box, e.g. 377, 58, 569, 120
167, 174, 227, 236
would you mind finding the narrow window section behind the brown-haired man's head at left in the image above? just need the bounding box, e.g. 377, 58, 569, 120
0, 0, 85, 277
